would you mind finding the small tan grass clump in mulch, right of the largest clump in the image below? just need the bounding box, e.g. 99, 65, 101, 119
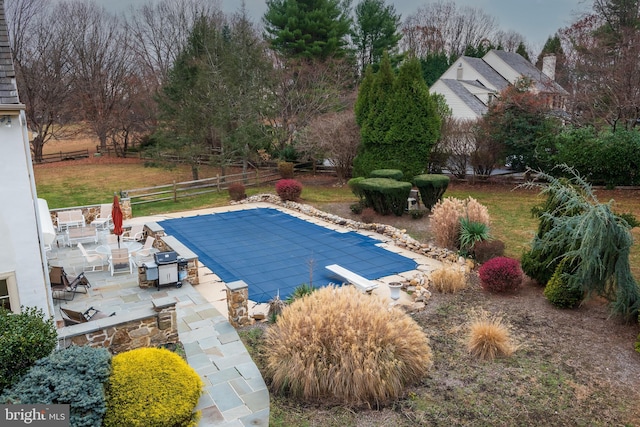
467, 310, 517, 360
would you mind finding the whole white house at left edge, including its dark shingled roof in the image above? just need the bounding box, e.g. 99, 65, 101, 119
0, 0, 53, 317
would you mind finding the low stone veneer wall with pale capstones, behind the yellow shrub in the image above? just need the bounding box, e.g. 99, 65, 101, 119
58, 298, 178, 354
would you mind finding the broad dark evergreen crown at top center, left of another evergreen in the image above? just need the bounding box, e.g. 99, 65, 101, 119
263, 0, 351, 60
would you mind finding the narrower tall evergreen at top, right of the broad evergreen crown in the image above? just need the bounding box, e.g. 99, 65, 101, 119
352, 0, 402, 72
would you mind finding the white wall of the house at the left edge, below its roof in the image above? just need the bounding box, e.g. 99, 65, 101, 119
0, 109, 53, 316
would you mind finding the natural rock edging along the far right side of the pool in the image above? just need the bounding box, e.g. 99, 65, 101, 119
231, 193, 464, 264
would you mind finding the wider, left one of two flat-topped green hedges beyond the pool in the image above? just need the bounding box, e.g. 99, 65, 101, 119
358, 178, 412, 216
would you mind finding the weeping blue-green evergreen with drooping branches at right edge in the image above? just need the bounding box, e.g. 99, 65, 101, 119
525, 165, 640, 319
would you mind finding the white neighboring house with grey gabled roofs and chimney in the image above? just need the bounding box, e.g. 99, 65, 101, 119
429, 50, 569, 120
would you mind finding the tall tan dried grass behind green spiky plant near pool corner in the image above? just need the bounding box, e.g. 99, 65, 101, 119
429, 197, 491, 250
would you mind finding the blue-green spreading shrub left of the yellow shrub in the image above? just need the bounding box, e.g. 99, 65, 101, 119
0, 346, 111, 427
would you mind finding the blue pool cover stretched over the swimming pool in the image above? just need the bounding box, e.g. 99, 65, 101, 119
160, 208, 416, 303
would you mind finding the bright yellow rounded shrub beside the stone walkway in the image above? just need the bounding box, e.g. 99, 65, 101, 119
103, 348, 203, 427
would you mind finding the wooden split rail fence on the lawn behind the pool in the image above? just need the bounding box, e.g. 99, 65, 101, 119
123, 169, 280, 205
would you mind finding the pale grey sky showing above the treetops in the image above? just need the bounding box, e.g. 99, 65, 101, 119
97, 0, 592, 50
